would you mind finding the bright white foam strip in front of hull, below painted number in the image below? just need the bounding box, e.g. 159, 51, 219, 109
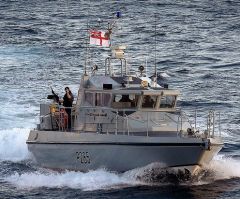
4, 169, 139, 191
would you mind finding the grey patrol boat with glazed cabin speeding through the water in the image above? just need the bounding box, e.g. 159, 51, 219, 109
27, 43, 223, 175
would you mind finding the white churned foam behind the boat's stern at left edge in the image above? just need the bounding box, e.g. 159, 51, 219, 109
0, 128, 30, 161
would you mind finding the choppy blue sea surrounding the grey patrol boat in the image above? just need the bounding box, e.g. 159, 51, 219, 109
0, 0, 240, 199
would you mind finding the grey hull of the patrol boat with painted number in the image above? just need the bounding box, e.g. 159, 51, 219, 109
27, 131, 222, 172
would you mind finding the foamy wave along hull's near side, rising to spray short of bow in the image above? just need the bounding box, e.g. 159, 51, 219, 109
2, 163, 182, 191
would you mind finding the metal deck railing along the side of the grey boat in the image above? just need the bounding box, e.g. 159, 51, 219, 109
43, 106, 221, 137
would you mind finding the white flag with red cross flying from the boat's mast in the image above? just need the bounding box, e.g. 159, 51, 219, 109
90, 30, 110, 47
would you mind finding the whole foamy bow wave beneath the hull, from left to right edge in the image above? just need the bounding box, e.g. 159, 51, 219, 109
1, 155, 240, 191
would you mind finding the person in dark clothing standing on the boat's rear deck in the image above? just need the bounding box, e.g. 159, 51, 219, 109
63, 87, 74, 129
